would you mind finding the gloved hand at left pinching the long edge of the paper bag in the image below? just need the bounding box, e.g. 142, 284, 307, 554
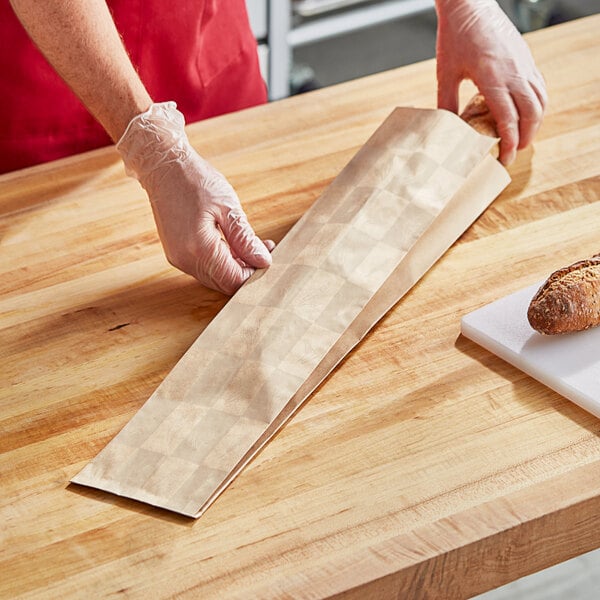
117, 102, 275, 294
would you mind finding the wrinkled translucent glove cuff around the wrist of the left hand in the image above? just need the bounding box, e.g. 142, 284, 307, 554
116, 102, 189, 181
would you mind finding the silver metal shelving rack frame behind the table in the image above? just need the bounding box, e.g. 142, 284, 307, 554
267, 0, 434, 100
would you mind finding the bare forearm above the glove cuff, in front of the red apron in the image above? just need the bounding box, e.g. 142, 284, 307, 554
10, 0, 151, 141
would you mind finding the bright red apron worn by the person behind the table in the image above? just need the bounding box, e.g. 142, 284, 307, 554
0, 0, 266, 173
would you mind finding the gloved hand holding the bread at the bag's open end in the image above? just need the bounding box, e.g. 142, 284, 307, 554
436, 0, 547, 165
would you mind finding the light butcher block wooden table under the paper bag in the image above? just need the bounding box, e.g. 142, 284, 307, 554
0, 16, 600, 599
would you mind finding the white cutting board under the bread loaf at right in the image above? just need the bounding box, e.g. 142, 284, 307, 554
461, 282, 600, 417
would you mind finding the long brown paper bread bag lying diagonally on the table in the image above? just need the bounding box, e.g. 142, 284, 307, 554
73, 108, 509, 517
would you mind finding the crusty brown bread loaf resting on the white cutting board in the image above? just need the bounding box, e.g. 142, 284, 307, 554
527, 254, 600, 334
